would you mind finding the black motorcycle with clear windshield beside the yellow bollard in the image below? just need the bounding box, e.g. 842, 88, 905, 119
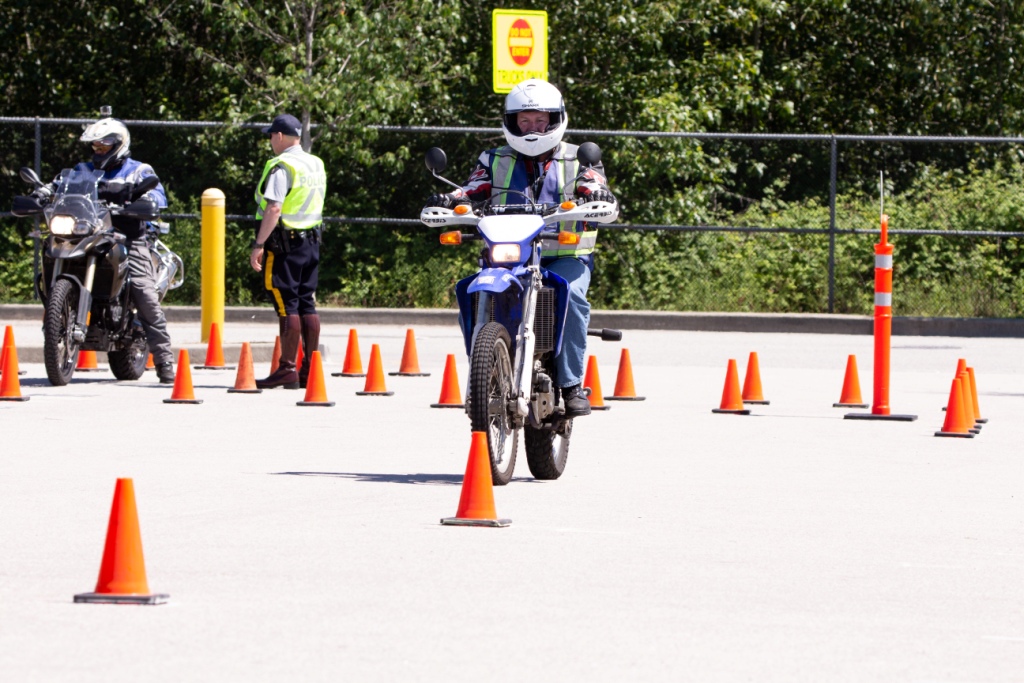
12, 166, 183, 386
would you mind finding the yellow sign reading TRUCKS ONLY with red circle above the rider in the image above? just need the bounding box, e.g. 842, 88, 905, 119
492, 9, 548, 92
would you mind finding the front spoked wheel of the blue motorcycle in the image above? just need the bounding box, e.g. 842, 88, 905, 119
467, 323, 519, 486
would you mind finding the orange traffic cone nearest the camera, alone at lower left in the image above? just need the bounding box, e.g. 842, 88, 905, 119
75, 479, 170, 605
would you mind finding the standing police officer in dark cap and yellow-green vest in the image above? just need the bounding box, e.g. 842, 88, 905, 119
249, 114, 327, 389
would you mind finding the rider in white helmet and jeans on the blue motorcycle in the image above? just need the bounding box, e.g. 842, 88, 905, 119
427, 79, 615, 418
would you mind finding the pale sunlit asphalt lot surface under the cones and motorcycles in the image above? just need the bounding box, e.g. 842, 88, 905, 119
0, 318, 1024, 683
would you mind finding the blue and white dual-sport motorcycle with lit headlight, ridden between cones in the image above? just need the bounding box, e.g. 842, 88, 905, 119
420, 142, 622, 485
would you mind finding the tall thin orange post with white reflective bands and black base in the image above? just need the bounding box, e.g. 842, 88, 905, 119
844, 214, 918, 422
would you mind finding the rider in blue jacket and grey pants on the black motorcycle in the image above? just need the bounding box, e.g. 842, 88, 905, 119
33, 117, 174, 384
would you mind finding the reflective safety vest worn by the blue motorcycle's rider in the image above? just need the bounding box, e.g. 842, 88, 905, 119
490, 142, 597, 258
